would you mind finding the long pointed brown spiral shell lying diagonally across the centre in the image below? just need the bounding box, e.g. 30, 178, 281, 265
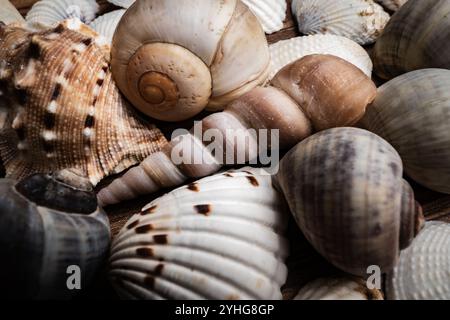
98, 55, 376, 205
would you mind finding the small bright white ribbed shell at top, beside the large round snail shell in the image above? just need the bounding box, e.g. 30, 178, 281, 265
242, 0, 287, 34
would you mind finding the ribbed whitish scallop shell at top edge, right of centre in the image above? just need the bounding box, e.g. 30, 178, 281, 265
292, 0, 390, 45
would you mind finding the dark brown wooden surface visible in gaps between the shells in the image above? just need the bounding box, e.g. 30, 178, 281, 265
6, 0, 450, 299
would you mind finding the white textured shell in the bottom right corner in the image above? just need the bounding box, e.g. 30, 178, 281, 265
386, 222, 450, 300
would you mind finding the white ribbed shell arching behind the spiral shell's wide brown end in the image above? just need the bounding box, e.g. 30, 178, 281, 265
269, 35, 373, 79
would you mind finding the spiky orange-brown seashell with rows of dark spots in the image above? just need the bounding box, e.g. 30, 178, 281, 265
0, 20, 166, 185
